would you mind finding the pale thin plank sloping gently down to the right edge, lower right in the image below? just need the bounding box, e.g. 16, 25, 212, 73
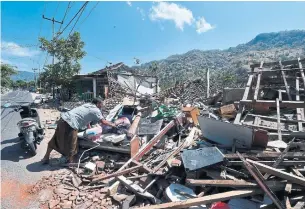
247, 159, 305, 186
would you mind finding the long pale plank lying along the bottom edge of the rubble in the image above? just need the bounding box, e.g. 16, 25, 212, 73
140, 187, 284, 209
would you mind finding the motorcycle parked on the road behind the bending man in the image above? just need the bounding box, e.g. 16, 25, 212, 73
15, 104, 44, 156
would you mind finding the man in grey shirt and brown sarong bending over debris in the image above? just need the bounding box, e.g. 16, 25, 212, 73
42, 99, 116, 164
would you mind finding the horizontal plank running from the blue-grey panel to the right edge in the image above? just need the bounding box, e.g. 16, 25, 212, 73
225, 152, 305, 159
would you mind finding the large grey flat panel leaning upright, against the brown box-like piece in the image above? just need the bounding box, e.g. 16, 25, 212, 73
198, 116, 253, 148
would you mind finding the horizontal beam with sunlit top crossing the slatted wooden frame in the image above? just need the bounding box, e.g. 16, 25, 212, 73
240, 100, 305, 109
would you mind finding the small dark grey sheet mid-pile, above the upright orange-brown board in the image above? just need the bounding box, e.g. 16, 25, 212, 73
138, 118, 163, 135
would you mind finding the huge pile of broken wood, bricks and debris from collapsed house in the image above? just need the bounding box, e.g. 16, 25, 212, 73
32, 60, 305, 209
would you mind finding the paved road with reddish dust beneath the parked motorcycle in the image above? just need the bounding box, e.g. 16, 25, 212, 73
1, 91, 50, 209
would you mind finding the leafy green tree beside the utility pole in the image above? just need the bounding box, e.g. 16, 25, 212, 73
39, 32, 86, 88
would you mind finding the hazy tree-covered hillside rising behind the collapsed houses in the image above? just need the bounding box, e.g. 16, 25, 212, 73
134, 30, 305, 91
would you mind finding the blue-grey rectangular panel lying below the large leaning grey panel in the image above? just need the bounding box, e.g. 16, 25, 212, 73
182, 147, 224, 171
